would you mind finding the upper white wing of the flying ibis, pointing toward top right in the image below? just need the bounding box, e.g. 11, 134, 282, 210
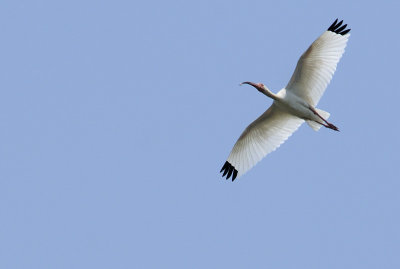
286, 19, 350, 106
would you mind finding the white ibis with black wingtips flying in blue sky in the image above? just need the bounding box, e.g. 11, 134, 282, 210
220, 19, 351, 181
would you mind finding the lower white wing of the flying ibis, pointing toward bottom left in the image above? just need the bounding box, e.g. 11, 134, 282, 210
221, 104, 304, 181
